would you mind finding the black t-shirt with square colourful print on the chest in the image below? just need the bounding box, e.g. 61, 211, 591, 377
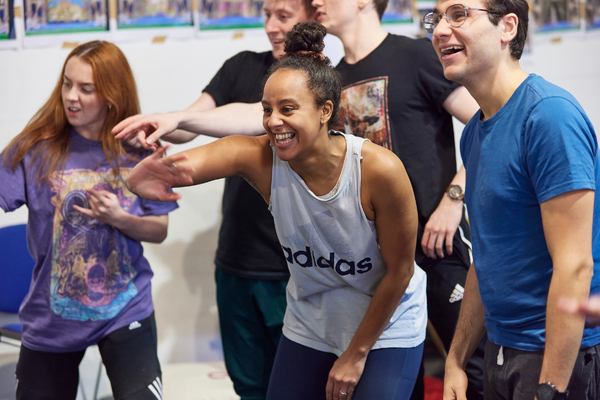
336, 34, 459, 262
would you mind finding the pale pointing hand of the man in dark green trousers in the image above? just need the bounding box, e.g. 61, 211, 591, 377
111, 112, 180, 150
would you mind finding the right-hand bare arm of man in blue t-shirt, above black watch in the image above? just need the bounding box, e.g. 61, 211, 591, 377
540, 190, 594, 392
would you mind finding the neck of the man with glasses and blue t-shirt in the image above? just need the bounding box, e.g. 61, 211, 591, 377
464, 60, 528, 121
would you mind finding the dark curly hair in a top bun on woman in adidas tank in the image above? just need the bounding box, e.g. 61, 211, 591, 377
263, 21, 342, 126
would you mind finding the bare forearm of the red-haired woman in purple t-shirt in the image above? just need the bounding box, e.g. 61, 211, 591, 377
110, 212, 169, 243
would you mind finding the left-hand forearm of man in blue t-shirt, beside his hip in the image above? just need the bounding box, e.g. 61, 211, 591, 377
446, 265, 485, 370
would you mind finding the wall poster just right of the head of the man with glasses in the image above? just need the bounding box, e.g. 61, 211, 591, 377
533, 0, 581, 33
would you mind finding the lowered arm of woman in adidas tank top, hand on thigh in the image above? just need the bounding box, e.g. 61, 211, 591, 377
326, 142, 417, 400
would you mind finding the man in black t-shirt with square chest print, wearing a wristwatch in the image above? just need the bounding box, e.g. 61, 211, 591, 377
312, 0, 483, 400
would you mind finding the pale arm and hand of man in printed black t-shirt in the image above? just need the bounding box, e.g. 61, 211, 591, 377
421, 86, 479, 258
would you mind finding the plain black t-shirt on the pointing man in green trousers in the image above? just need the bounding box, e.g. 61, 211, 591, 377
204, 51, 289, 279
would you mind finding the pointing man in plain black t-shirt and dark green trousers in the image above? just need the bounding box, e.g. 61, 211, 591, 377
115, 0, 314, 400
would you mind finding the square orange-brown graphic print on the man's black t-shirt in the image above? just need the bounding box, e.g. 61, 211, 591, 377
340, 76, 392, 150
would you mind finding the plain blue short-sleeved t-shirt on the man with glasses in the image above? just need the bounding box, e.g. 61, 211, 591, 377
461, 75, 600, 351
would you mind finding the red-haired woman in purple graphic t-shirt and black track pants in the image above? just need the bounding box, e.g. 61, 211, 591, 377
0, 41, 177, 400
